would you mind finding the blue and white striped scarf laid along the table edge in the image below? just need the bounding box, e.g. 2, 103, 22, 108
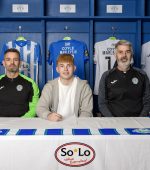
0, 128, 150, 136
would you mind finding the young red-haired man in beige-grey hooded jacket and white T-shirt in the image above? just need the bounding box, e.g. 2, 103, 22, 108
36, 54, 93, 121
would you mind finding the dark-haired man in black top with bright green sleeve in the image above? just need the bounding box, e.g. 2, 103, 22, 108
0, 49, 39, 118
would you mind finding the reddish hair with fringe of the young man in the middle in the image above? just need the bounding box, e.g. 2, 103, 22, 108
57, 53, 74, 65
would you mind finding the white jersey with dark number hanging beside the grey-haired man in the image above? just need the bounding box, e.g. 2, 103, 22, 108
94, 39, 119, 95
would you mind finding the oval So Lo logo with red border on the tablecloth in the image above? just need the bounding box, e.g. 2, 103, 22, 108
55, 142, 95, 167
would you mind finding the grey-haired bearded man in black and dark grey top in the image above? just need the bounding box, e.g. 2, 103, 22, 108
98, 40, 150, 117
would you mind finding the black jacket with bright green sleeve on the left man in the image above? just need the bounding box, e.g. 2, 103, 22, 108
0, 74, 39, 117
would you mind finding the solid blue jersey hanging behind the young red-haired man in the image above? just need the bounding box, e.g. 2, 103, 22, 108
48, 40, 89, 79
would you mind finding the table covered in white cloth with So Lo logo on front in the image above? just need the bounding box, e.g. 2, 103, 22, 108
0, 117, 150, 170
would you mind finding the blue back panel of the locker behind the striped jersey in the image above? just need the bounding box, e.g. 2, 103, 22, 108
0, 21, 45, 88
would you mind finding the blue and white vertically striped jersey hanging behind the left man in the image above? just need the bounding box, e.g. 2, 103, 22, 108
0, 40, 41, 83
